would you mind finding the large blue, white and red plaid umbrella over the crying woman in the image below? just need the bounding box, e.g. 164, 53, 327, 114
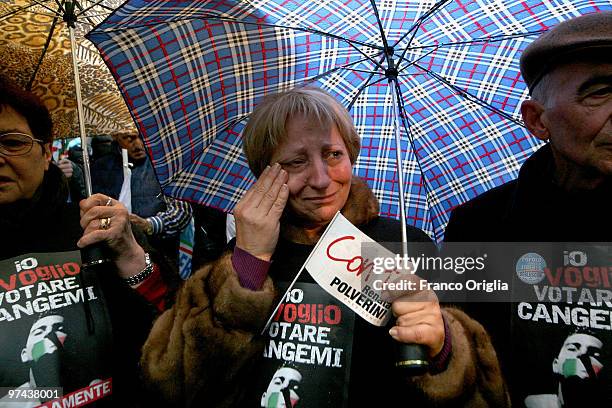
88, 0, 612, 239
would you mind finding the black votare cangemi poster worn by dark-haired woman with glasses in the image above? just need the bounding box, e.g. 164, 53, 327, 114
0, 251, 112, 407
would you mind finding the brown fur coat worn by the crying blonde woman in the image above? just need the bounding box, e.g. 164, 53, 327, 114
141, 177, 508, 407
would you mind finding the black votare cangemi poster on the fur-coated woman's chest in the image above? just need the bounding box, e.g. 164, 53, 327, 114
251, 282, 355, 408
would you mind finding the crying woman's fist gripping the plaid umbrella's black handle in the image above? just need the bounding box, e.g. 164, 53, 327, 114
389, 290, 444, 357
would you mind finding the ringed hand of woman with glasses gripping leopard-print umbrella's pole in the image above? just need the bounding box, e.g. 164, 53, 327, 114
77, 194, 146, 278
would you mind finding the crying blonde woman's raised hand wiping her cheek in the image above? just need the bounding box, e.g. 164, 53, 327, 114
234, 163, 289, 261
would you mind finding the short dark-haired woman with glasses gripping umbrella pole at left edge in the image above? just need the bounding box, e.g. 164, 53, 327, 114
0, 78, 165, 406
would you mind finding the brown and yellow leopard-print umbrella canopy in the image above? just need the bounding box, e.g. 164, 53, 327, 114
0, 0, 134, 138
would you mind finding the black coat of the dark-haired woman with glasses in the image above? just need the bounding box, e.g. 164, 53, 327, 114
0, 164, 155, 407
